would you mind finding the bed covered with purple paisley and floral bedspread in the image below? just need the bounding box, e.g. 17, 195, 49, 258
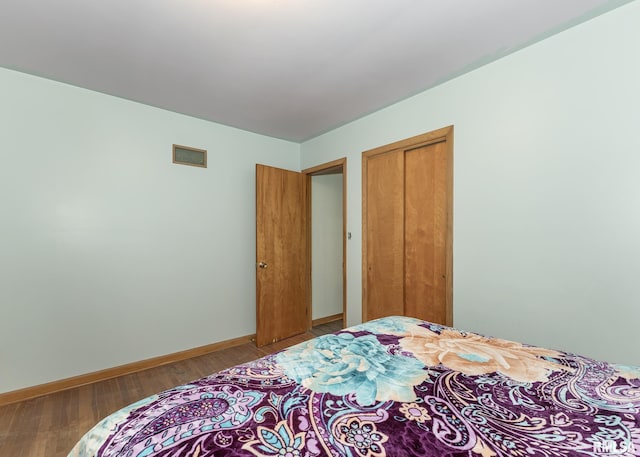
69, 317, 640, 457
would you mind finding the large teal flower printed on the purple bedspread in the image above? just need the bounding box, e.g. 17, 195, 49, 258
276, 333, 428, 405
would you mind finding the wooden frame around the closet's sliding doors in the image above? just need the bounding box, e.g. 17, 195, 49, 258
362, 125, 453, 326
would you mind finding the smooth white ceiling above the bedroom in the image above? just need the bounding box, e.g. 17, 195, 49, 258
0, 0, 630, 141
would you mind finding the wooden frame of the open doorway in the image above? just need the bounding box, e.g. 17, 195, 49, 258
302, 157, 347, 329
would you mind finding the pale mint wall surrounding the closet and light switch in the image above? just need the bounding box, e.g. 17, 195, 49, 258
301, 2, 640, 364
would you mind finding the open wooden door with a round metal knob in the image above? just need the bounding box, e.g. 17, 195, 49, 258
256, 164, 309, 346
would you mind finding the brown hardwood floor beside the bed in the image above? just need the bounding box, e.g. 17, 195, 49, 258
0, 321, 342, 457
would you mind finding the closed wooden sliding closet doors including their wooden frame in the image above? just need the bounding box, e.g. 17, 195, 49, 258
362, 127, 453, 325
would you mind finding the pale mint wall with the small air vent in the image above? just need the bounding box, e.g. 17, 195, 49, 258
0, 69, 300, 392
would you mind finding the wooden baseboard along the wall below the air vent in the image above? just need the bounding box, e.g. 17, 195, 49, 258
0, 335, 256, 406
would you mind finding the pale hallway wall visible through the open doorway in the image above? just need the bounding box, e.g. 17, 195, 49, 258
311, 174, 343, 319
